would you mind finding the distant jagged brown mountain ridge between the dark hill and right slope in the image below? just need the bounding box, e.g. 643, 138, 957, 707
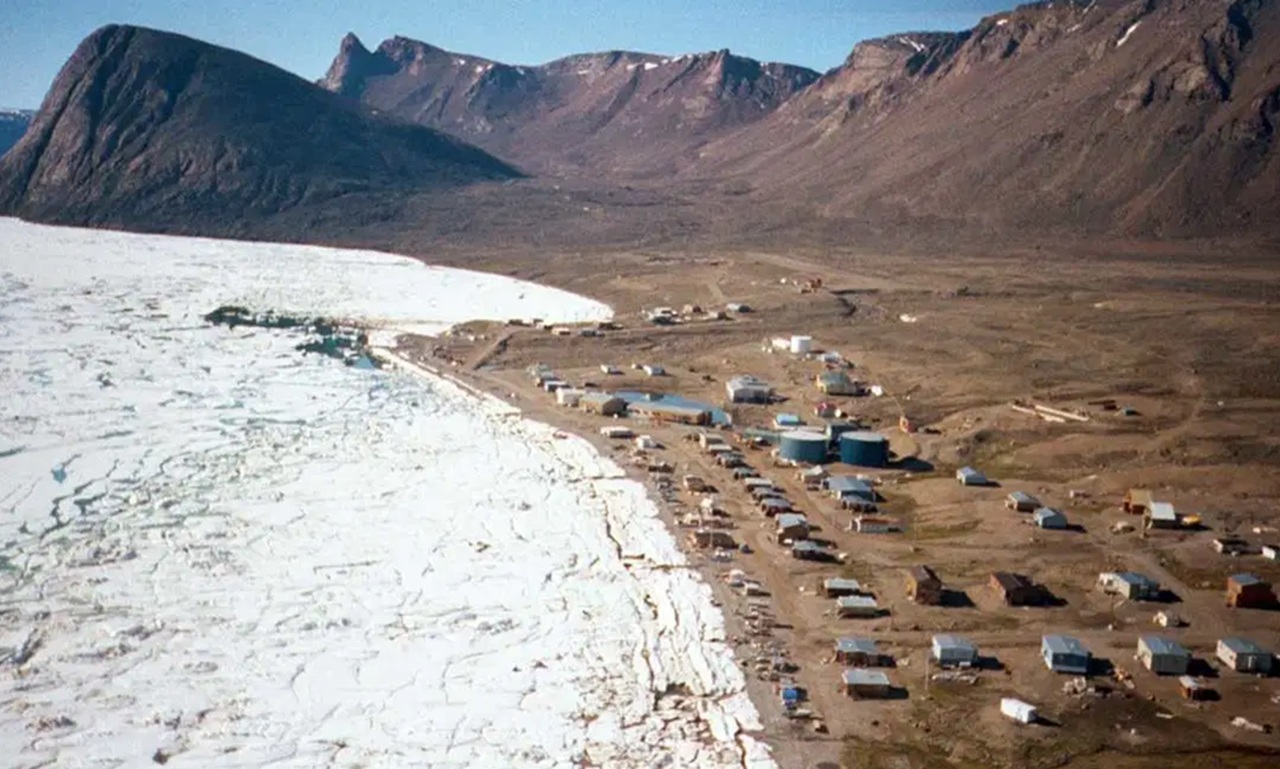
320, 35, 818, 178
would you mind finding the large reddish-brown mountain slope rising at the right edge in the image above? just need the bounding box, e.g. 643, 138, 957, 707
694, 0, 1280, 235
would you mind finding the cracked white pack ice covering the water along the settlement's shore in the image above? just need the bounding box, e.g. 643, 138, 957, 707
0, 220, 772, 768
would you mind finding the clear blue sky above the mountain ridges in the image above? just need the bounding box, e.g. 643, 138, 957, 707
0, 0, 1023, 107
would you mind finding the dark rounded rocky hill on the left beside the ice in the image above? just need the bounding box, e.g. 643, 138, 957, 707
0, 26, 518, 233
